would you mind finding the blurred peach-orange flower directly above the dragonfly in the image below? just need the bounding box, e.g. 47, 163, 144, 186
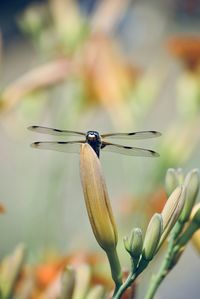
81, 33, 140, 126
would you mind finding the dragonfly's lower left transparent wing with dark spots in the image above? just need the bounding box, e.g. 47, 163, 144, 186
31, 140, 85, 154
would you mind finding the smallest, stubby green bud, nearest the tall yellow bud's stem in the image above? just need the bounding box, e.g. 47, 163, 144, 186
123, 228, 143, 259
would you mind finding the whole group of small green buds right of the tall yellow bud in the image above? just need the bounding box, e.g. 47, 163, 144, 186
124, 169, 200, 284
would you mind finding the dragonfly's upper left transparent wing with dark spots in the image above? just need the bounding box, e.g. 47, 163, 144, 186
28, 126, 85, 136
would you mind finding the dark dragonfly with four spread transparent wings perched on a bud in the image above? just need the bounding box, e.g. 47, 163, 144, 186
28, 126, 161, 158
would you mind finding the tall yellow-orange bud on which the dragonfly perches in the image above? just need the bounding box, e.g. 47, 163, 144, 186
80, 144, 117, 251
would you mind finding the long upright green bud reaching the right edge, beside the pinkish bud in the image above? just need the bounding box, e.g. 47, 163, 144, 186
180, 169, 199, 222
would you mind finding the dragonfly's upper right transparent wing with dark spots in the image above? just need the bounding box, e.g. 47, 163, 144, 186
101, 131, 161, 139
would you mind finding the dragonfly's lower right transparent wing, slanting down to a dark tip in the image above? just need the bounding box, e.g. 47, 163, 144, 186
101, 142, 159, 157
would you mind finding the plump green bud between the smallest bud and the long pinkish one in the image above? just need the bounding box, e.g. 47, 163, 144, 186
142, 214, 163, 261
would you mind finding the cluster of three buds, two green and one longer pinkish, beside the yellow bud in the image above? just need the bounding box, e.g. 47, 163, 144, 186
124, 186, 185, 269
